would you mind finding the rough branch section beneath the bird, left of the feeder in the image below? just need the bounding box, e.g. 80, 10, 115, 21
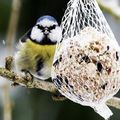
0, 68, 56, 93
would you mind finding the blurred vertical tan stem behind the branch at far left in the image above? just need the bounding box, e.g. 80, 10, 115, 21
3, 0, 21, 120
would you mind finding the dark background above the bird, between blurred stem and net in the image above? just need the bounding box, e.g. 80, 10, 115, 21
17, 0, 68, 40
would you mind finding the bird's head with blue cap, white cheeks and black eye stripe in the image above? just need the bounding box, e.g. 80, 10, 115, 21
30, 15, 62, 44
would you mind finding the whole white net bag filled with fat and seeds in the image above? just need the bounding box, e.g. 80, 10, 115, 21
51, 0, 120, 119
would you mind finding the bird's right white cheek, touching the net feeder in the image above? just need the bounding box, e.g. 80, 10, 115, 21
49, 27, 62, 42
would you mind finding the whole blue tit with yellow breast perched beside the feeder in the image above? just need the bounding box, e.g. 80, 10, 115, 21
15, 16, 62, 80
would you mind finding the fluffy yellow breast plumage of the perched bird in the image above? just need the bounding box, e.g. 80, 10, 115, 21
18, 40, 56, 71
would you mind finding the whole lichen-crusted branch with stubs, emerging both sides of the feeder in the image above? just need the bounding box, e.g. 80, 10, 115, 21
0, 57, 120, 109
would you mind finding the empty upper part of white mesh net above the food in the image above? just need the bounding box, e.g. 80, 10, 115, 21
61, 0, 115, 39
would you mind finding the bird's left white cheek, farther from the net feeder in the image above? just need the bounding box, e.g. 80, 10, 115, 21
31, 27, 44, 42
